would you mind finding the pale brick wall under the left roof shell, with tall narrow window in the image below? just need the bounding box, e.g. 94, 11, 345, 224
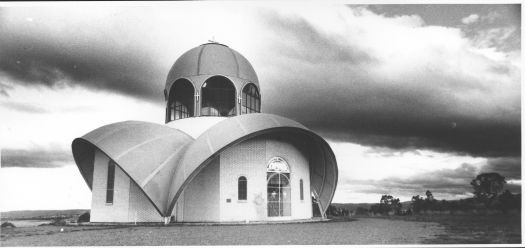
90, 150, 162, 222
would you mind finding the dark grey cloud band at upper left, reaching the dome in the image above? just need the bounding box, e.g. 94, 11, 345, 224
0, 10, 167, 102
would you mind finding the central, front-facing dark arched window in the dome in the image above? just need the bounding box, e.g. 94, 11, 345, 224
201, 76, 236, 116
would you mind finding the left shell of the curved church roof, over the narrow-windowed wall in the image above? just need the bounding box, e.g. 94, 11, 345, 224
72, 121, 193, 214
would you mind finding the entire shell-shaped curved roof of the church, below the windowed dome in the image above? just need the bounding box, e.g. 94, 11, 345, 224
72, 114, 338, 216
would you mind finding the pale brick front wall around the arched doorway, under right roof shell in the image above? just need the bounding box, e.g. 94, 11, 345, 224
220, 137, 312, 221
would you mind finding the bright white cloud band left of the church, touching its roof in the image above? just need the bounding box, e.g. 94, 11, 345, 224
0, 79, 164, 150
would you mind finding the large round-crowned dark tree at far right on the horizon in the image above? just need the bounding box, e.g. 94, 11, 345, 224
470, 172, 507, 204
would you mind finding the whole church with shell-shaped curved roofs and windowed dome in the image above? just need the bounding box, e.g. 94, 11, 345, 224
72, 42, 338, 223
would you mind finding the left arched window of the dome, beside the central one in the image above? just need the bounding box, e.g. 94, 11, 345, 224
166, 79, 195, 122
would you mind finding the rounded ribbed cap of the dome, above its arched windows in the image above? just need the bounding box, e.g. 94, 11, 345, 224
166, 42, 259, 86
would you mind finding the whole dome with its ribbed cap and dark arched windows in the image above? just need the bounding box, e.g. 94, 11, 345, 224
164, 43, 261, 123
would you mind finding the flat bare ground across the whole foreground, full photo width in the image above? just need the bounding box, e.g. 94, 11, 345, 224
0, 214, 522, 246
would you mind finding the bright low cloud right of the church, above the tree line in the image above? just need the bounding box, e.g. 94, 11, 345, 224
330, 142, 490, 202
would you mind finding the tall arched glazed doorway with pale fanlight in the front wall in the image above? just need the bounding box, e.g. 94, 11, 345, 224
266, 157, 292, 217
